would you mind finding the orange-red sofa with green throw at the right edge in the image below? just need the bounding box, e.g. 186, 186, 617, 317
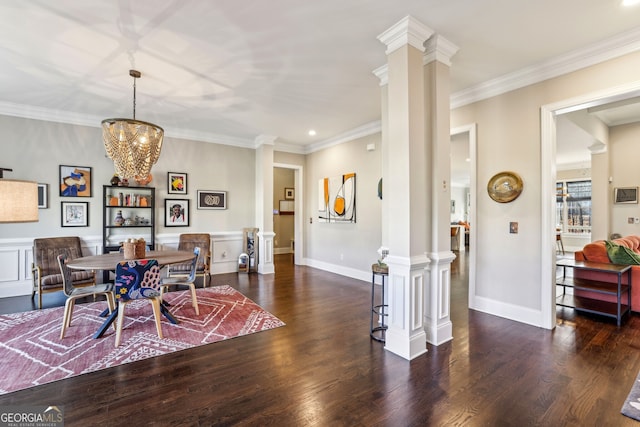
574, 236, 640, 313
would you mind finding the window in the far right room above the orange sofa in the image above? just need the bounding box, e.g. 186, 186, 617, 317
556, 180, 591, 234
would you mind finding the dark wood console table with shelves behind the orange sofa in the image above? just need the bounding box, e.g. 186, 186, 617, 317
556, 259, 631, 326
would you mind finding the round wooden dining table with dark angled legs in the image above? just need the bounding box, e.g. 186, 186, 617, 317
67, 250, 194, 339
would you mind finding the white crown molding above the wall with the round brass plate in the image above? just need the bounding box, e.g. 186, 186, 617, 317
451, 27, 640, 108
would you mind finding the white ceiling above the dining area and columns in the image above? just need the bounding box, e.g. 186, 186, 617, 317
0, 0, 640, 152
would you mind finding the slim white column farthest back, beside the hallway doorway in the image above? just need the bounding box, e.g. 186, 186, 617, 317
255, 135, 276, 274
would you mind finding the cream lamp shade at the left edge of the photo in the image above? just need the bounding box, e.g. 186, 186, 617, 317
0, 179, 38, 223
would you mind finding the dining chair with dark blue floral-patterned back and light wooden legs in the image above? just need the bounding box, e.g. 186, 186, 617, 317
114, 259, 162, 347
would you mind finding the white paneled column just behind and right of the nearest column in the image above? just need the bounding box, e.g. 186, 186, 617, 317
424, 34, 464, 345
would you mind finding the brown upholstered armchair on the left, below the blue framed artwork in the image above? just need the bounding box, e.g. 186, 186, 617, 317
31, 236, 96, 308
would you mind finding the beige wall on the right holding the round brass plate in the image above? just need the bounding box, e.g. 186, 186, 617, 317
451, 53, 640, 315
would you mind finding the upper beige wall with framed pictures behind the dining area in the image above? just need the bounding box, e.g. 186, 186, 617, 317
0, 116, 255, 238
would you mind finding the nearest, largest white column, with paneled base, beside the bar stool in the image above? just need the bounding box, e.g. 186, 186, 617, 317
378, 16, 432, 360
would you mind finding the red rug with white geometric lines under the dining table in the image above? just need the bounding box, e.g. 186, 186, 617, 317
0, 286, 284, 394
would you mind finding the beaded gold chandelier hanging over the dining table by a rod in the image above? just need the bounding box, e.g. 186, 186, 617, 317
102, 70, 164, 179
